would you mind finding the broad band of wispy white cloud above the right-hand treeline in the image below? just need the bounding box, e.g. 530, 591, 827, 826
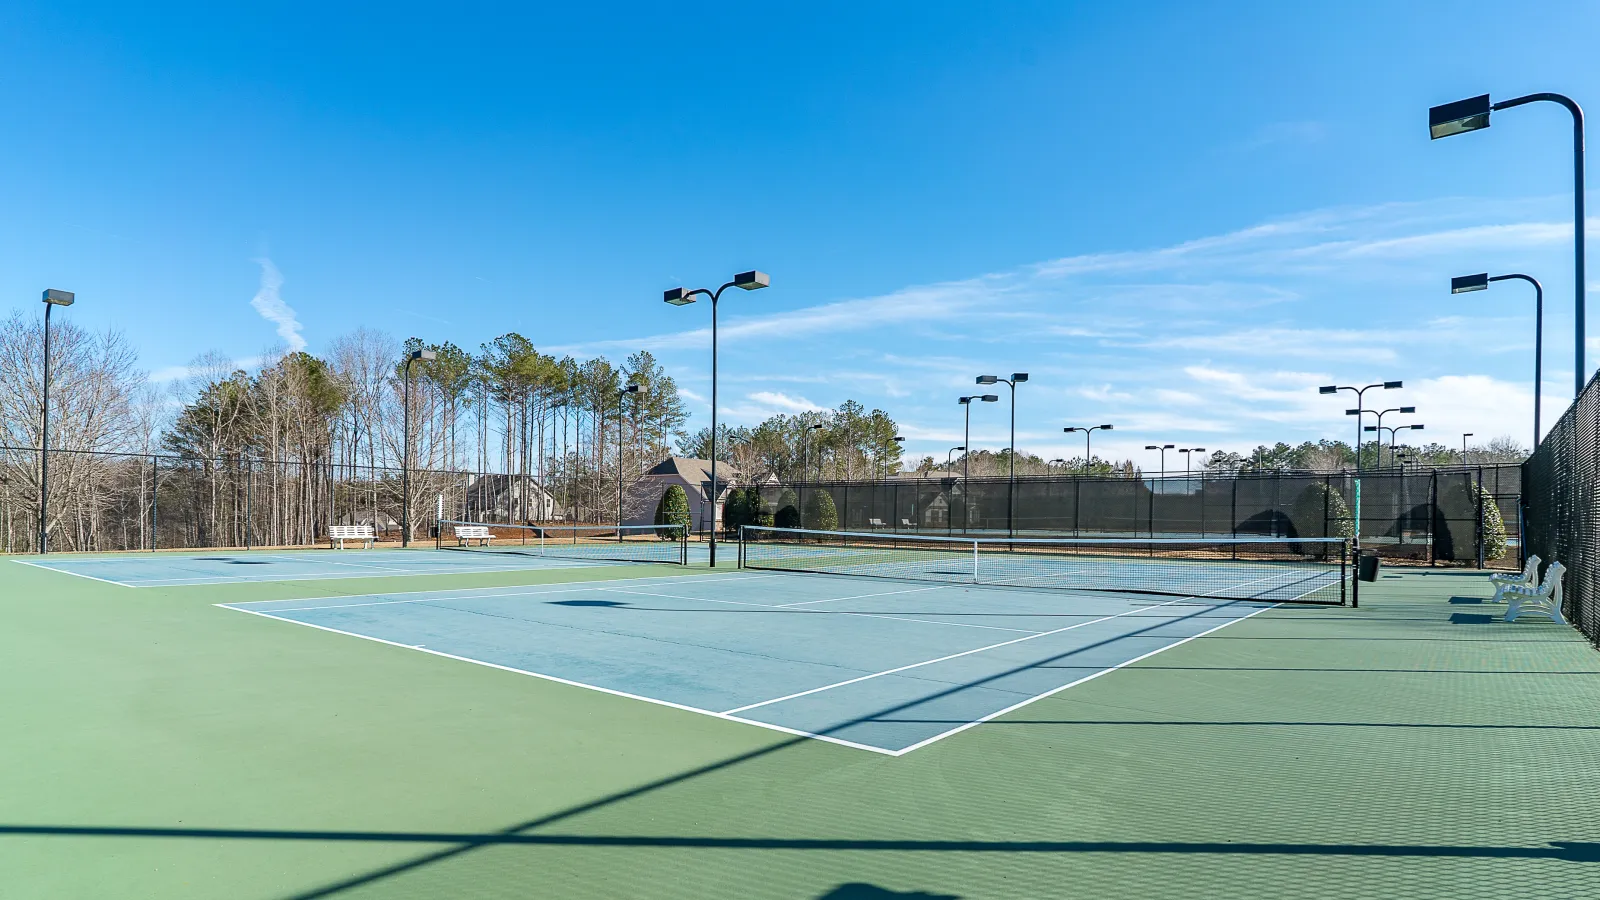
589, 199, 1571, 463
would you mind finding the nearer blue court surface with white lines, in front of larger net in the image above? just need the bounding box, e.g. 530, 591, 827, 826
218, 572, 1272, 756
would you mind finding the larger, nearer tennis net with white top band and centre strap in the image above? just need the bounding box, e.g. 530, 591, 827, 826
739, 525, 1355, 605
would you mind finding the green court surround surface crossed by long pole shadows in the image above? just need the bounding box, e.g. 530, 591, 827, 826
0, 551, 1600, 900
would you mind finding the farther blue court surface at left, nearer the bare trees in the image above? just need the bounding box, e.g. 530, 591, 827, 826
16, 544, 706, 588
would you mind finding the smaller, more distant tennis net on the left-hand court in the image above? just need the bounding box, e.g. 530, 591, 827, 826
435, 519, 688, 565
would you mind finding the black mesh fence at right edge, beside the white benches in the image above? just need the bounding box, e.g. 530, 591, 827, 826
1523, 375, 1600, 644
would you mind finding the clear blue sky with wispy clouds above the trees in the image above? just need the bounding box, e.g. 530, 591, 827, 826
0, 2, 1600, 463
